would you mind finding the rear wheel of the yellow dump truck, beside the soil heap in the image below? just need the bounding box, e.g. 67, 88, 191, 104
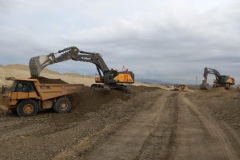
53, 97, 72, 113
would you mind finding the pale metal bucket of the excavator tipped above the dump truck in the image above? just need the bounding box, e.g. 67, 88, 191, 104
29, 55, 51, 77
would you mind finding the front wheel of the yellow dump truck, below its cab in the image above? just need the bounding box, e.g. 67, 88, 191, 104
17, 99, 38, 117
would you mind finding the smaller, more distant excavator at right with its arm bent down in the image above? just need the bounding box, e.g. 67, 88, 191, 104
200, 67, 235, 90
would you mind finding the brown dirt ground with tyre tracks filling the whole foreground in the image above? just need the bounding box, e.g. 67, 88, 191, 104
0, 86, 240, 160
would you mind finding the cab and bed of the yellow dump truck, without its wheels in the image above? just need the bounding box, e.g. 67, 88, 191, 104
2, 77, 84, 109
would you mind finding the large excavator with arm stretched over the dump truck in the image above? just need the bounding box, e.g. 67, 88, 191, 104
29, 46, 134, 93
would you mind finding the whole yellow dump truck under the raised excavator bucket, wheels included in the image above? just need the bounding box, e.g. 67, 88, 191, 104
0, 77, 84, 117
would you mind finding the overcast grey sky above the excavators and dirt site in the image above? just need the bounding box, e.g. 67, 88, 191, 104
0, 0, 240, 84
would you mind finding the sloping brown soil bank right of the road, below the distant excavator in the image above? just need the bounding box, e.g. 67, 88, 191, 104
188, 87, 240, 133
